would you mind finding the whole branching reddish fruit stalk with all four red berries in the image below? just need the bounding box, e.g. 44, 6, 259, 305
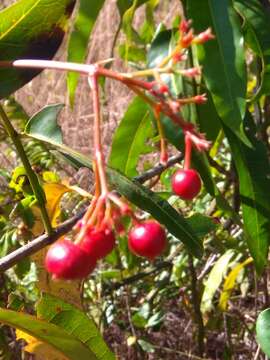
45, 20, 213, 280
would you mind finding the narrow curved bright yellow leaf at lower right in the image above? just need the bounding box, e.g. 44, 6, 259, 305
219, 257, 253, 311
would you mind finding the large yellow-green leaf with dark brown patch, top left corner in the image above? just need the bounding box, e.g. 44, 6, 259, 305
0, 0, 75, 98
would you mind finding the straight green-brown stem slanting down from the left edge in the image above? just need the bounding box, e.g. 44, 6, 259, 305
0, 105, 52, 235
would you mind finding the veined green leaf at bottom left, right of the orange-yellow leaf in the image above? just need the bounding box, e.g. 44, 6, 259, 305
37, 294, 115, 360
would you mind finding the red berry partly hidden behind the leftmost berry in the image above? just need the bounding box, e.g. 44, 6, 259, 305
80, 228, 115, 260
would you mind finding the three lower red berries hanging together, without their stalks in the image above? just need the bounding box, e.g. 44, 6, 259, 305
45, 220, 167, 280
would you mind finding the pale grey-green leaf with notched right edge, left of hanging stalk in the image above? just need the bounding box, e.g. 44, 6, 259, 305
24, 104, 64, 144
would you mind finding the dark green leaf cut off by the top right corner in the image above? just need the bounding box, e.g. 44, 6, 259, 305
233, 0, 270, 100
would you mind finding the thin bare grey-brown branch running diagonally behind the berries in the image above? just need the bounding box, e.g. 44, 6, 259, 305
0, 154, 183, 276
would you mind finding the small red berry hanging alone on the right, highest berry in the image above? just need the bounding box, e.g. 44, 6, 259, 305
172, 169, 202, 200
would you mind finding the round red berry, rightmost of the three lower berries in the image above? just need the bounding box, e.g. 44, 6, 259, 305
128, 220, 167, 260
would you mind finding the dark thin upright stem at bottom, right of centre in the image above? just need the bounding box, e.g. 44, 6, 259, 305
188, 254, 205, 357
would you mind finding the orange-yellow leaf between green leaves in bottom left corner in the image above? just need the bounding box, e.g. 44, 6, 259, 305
16, 329, 68, 360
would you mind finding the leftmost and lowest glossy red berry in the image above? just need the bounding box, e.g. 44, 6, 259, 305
45, 239, 96, 280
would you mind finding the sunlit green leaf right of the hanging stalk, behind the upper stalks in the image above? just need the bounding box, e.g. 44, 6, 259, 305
109, 98, 152, 177
